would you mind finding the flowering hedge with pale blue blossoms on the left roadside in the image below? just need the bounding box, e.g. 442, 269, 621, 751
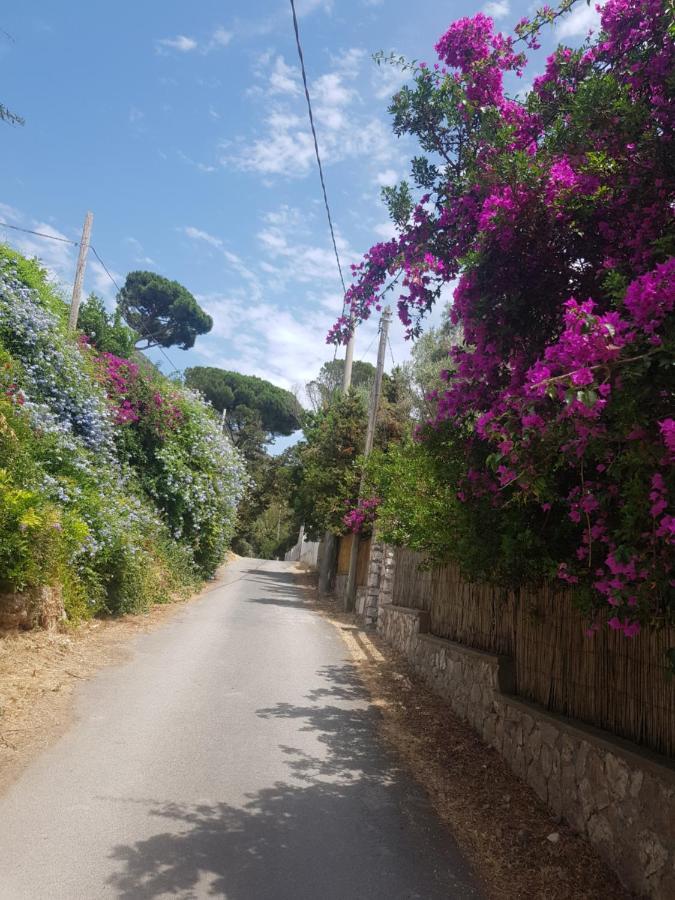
0, 248, 243, 618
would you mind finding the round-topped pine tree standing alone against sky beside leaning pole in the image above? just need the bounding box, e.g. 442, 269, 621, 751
117, 272, 213, 350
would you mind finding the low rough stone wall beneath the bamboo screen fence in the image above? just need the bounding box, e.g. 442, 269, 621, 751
378, 604, 675, 900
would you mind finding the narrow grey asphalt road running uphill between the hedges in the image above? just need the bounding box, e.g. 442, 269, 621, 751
0, 559, 480, 900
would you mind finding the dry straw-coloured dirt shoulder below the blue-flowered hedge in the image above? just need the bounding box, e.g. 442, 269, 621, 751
0, 556, 235, 793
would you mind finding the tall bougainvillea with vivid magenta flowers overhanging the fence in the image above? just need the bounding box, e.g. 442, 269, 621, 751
329, 0, 675, 636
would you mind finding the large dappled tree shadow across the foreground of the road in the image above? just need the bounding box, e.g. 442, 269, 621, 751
109, 665, 479, 900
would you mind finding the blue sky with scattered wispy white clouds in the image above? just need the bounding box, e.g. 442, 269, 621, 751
0, 0, 596, 400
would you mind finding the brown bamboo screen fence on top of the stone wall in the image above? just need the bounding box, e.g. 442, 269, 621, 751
393, 549, 675, 755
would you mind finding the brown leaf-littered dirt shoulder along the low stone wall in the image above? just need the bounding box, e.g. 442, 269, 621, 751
316, 601, 631, 900
